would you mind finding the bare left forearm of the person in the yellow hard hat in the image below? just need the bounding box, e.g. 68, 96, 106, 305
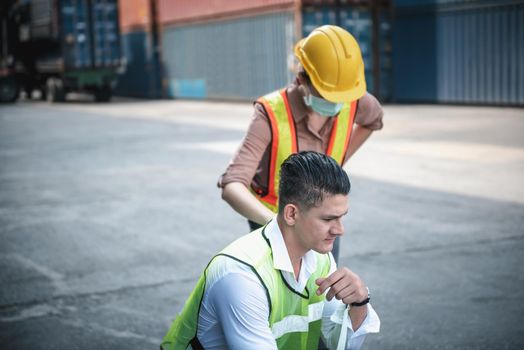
222, 182, 275, 225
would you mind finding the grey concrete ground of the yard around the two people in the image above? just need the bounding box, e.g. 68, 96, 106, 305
0, 98, 524, 350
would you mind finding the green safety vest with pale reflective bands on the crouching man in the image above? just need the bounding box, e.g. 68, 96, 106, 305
161, 227, 330, 350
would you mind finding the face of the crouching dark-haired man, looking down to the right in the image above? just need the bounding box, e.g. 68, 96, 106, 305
295, 194, 349, 254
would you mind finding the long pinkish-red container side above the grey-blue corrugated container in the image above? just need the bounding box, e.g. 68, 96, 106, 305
158, 0, 299, 24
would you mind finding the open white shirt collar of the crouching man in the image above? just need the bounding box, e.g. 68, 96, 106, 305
264, 217, 317, 277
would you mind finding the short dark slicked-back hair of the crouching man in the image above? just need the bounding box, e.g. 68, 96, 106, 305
278, 151, 351, 212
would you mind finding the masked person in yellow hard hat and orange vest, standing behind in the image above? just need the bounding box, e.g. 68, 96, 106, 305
218, 25, 383, 260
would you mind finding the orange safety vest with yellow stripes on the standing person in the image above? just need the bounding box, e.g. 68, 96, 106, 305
251, 89, 358, 213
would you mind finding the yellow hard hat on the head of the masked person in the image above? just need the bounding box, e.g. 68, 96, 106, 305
295, 25, 366, 102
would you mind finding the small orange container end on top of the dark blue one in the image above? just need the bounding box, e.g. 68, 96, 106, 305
118, 0, 152, 33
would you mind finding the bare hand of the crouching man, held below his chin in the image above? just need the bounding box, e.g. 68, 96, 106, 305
315, 267, 368, 304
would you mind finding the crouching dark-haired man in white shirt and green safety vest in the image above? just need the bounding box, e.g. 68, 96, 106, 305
162, 152, 380, 350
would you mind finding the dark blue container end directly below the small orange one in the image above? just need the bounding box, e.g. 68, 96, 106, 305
115, 31, 161, 98
